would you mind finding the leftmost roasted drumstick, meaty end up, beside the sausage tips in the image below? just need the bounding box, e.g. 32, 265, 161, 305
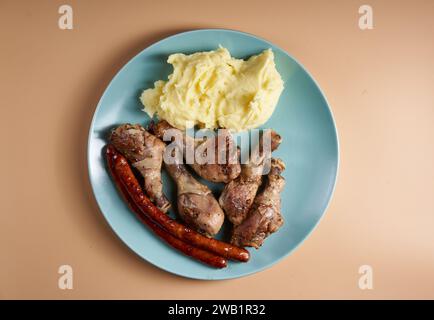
110, 123, 170, 212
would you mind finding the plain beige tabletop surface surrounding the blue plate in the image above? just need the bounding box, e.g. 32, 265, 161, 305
0, 0, 434, 299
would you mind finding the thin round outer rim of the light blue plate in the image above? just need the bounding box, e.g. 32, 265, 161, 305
86, 28, 340, 281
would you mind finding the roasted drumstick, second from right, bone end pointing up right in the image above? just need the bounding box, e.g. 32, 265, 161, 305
219, 131, 282, 225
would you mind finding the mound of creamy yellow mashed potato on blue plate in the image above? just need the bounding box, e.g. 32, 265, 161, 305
140, 48, 283, 131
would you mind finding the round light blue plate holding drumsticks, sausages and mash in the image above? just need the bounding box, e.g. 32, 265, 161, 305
88, 29, 339, 280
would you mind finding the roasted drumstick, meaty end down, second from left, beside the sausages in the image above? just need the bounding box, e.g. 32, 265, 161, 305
165, 163, 224, 237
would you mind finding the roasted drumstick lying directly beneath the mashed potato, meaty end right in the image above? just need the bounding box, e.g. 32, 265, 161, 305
151, 120, 241, 183
